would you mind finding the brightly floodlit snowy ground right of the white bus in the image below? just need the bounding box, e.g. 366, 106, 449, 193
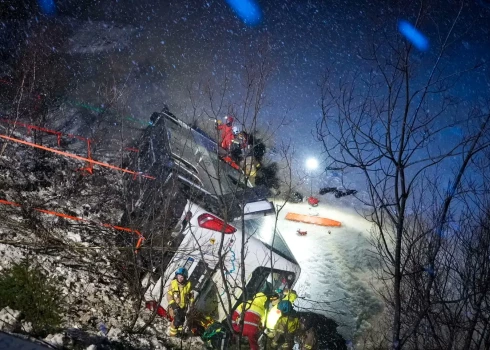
278, 196, 382, 341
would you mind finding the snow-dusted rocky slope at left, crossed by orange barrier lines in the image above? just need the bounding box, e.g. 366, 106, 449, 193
0, 145, 202, 349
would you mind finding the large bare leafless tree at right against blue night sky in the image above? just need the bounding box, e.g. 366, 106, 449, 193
317, 4, 490, 349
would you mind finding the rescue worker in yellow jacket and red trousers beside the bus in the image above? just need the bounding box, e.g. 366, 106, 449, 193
231, 292, 268, 350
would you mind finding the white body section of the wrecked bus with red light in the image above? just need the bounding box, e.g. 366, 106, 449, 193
146, 201, 301, 321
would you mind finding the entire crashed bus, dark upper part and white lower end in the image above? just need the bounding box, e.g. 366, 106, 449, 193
142, 110, 301, 328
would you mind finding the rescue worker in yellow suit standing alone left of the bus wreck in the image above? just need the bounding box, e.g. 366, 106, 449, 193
167, 267, 194, 337
